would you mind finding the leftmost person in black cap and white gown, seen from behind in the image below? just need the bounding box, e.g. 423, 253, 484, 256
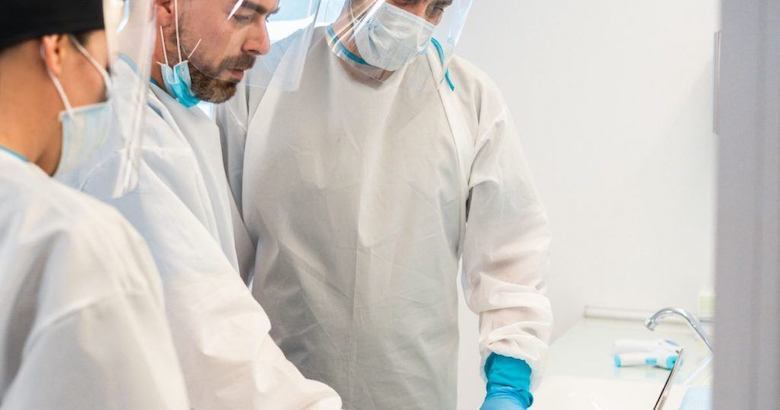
0, 0, 189, 410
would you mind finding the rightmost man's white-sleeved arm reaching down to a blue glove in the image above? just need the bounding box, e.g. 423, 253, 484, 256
463, 104, 552, 399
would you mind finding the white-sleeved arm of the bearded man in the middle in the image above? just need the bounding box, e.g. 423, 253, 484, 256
87, 162, 341, 410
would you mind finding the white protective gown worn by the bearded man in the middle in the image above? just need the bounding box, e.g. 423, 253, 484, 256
61, 85, 341, 410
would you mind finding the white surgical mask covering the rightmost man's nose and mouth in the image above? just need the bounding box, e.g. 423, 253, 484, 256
354, 2, 436, 71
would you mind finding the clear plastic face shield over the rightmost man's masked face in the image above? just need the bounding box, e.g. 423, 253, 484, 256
317, 0, 472, 85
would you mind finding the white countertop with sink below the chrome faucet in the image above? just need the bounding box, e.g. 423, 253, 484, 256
533, 319, 712, 410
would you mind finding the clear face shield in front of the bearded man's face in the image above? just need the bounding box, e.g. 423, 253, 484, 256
157, 0, 319, 102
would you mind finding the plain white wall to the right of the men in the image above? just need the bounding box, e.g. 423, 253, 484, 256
458, 0, 719, 410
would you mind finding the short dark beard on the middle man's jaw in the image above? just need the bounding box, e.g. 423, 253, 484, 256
189, 55, 255, 103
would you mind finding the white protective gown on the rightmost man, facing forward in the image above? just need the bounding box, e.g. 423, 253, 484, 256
218, 29, 552, 410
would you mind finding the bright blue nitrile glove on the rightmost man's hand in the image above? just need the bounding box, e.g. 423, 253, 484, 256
480, 353, 534, 410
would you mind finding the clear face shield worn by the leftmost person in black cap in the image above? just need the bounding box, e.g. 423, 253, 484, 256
49, 0, 155, 197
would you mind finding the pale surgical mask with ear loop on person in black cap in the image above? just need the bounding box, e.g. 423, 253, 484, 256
48, 37, 112, 178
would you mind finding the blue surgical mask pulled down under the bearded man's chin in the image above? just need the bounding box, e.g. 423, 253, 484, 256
157, 1, 200, 108
